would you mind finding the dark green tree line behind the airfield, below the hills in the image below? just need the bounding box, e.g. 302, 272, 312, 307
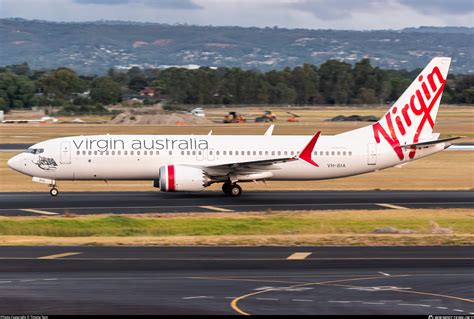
0, 59, 474, 112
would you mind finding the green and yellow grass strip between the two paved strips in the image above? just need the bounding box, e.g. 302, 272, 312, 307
0, 212, 473, 237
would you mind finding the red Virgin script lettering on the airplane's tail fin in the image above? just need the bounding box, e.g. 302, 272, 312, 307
372, 66, 446, 160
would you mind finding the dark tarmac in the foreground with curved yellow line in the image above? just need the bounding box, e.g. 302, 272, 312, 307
0, 247, 474, 315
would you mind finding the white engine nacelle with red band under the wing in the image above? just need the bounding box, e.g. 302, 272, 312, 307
153, 165, 208, 192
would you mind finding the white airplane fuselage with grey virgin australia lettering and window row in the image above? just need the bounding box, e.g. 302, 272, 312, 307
9, 128, 444, 184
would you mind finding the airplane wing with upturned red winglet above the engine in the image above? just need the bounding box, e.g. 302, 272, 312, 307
196, 132, 321, 180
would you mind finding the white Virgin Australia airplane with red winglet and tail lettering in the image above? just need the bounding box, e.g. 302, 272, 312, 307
8, 57, 460, 197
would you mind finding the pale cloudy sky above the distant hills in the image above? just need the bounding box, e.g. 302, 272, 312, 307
0, 0, 474, 30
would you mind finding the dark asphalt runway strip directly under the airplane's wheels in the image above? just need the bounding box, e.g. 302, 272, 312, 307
0, 191, 474, 216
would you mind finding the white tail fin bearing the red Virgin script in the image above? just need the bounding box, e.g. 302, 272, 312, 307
372, 58, 451, 160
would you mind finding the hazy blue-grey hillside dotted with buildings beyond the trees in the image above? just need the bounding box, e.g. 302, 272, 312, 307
0, 19, 474, 74
